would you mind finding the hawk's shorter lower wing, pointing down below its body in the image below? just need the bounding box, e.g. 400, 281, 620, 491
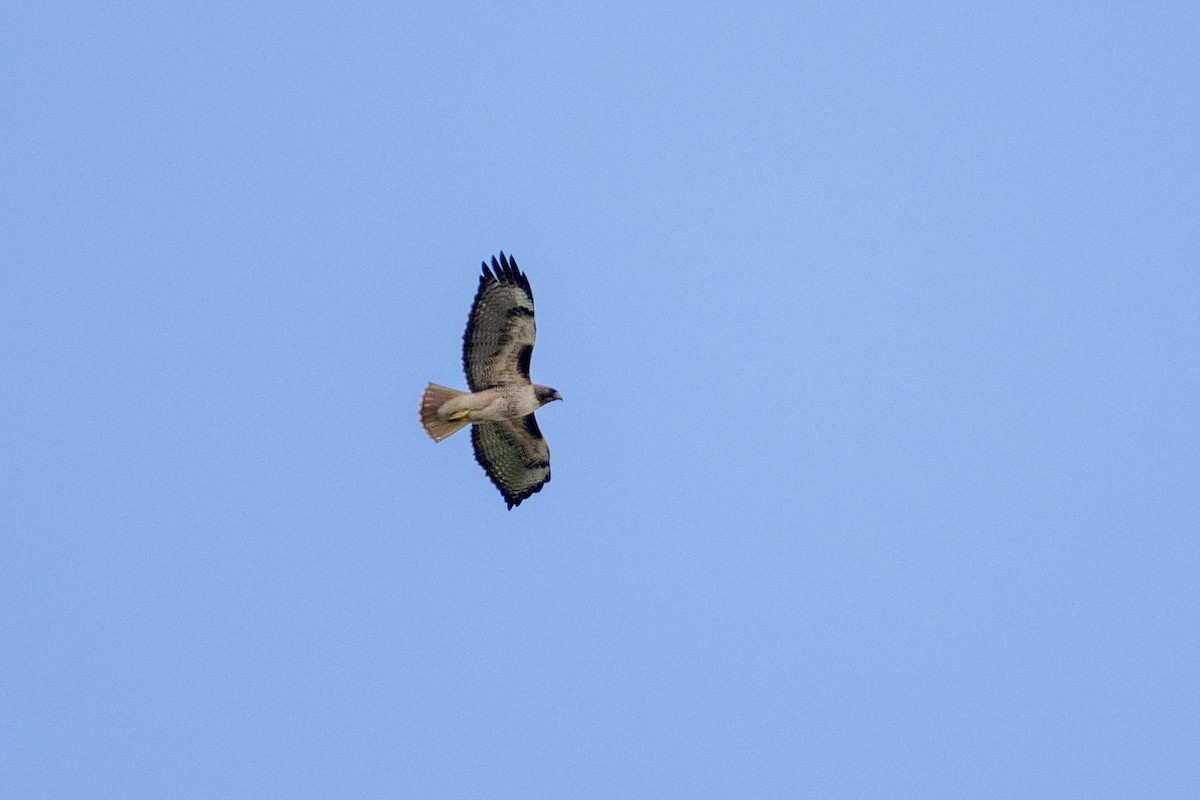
470, 414, 550, 509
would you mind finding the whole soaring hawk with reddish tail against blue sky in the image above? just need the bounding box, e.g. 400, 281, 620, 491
421, 252, 563, 510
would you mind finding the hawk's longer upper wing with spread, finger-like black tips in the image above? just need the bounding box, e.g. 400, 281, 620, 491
462, 252, 538, 392
